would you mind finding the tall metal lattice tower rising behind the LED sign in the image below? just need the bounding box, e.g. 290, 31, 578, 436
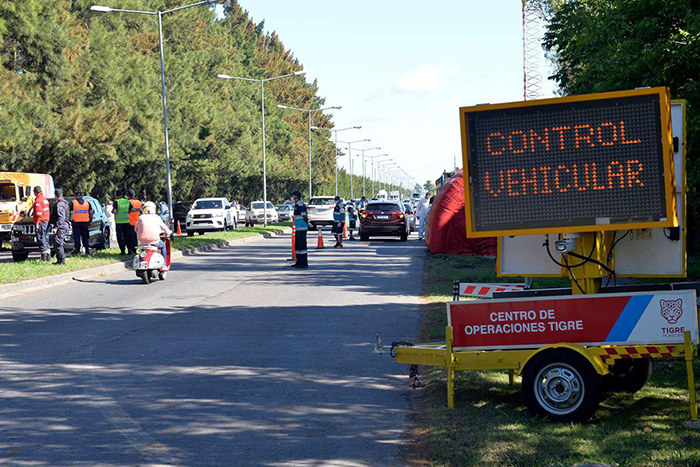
522, 0, 543, 101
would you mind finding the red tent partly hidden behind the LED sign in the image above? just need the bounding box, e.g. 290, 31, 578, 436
426, 170, 496, 256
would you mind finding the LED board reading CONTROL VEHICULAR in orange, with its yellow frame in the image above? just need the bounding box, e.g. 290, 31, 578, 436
460, 88, 675, 237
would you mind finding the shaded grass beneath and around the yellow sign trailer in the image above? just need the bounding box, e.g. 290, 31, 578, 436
408, 256, 700, 467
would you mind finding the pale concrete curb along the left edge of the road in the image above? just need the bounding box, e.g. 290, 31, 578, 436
0, 227, 292, 300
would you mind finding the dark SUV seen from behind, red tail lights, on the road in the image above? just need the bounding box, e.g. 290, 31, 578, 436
360, 201, 410, 242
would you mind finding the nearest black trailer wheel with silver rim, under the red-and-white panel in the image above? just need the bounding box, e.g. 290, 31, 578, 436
522, 349, 600, 422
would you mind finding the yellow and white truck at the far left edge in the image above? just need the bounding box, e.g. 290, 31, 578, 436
0, 172, 54, 241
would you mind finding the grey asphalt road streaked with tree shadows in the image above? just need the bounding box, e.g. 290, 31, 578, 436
0, 234, 425, 467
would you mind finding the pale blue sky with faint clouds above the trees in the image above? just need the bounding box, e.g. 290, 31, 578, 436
227, 0, 556, 190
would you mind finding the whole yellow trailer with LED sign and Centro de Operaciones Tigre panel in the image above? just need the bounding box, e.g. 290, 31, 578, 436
375, 88, 700, 422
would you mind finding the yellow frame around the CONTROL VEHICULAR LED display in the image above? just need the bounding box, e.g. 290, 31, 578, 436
459, 87, 678, 238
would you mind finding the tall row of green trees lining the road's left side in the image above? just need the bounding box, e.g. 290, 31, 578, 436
0, 0, 350, 203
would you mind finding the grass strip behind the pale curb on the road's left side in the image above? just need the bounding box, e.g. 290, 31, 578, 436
0, 222, 291, 284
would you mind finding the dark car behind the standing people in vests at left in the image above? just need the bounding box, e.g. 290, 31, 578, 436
12, 196, 110, 261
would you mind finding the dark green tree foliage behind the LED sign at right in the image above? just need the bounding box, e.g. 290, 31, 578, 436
544, 0, 700, 252
